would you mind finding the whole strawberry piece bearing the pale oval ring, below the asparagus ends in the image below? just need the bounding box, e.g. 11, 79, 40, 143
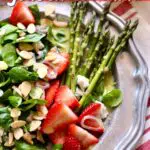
78, 103, 104, 133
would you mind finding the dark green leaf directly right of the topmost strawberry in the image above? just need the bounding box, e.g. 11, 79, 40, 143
29, 4, 41, 24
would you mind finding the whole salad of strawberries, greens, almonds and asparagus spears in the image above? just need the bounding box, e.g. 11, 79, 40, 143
0, 2, 138, 150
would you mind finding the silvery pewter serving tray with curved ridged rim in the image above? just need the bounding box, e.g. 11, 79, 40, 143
0, 1, 149, 150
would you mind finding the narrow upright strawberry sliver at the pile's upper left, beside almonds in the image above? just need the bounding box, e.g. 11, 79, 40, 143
45, 80, 60, 107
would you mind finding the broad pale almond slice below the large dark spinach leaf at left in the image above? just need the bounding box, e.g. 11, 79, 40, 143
18, 81, 32, 97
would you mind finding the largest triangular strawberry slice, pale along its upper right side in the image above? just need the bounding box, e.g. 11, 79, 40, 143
41, 103, 78, 134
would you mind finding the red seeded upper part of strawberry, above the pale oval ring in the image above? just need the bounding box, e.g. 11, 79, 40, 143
78, 103, 101, 122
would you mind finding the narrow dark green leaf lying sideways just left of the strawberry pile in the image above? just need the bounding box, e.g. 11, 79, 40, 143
22, 99, 46, 111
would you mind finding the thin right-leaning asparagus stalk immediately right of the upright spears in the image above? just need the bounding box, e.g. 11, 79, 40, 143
76, 12, 96, 67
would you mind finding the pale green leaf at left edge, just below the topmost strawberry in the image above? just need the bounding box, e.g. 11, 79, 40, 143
0, 24, 18, 36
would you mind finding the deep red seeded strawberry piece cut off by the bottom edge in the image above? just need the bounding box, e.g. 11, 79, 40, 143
63, 136, 81, 150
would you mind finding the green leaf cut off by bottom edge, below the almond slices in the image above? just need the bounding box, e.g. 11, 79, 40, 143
15, 141, 46, 150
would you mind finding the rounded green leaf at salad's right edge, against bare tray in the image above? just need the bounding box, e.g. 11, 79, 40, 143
102, 89, 122, 108
